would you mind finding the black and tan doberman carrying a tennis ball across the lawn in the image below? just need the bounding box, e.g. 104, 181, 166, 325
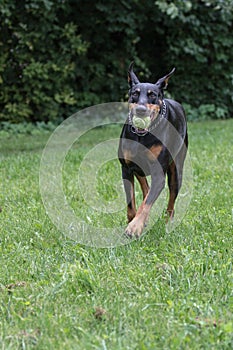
118, 62, 188, 237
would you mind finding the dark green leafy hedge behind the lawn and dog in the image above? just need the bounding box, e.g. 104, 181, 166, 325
0, 0, 233, 123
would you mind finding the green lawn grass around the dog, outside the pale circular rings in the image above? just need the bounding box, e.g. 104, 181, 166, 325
0, 120, 233, 350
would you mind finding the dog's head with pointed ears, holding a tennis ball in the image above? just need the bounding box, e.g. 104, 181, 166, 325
128, 62, 175, 133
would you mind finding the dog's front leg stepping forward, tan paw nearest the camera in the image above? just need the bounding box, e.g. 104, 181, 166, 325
126, 167, 165, 238
